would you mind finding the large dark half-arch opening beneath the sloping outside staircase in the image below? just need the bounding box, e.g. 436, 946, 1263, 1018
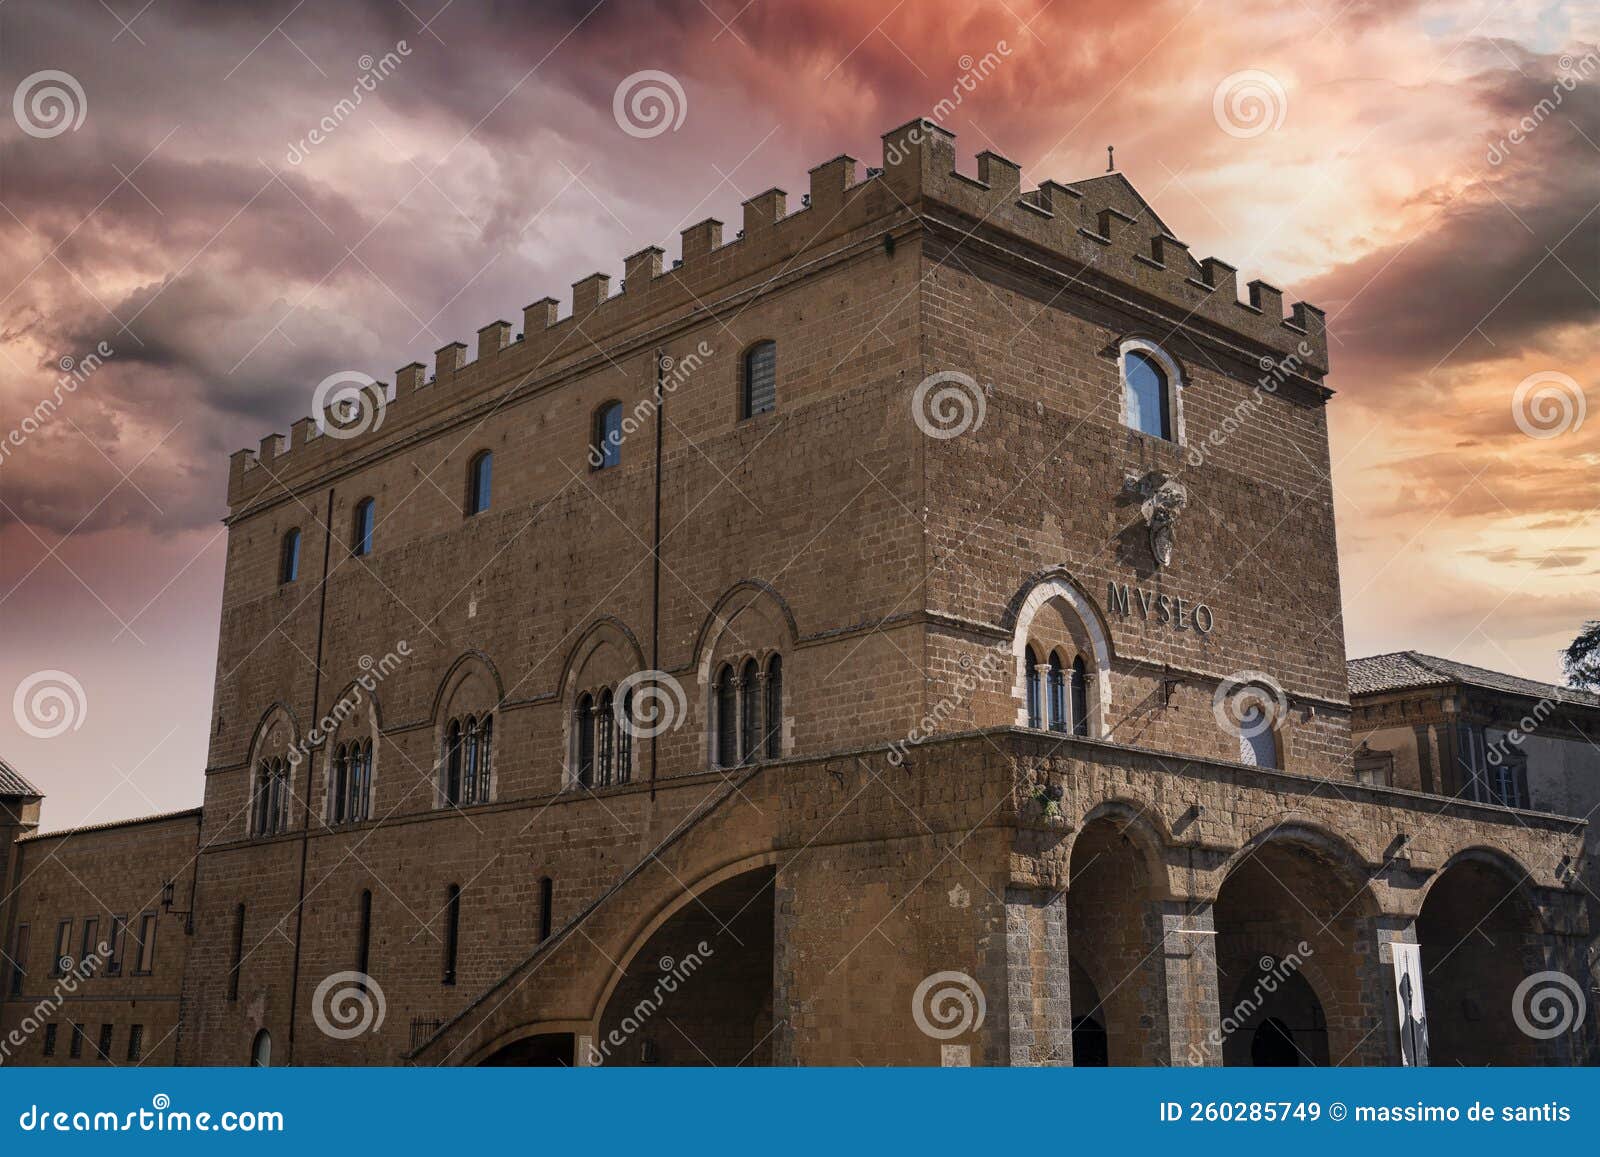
589, 867, 774, 1066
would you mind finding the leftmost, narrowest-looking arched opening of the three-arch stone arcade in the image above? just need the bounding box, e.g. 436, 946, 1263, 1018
1067, 816, 1166, 1066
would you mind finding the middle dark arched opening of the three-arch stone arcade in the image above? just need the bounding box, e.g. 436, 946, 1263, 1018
1213, 834, 1389, 1066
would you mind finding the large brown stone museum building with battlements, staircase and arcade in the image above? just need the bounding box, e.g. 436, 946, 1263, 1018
0, 122, 1592, 1064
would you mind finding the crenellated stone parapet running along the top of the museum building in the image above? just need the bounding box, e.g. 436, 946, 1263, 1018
229, 118, 1328, 512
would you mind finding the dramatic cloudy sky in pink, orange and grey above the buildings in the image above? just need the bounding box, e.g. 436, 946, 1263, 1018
0, 0, 1600, 827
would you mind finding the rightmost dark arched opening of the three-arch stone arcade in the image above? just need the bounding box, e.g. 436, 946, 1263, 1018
1416, 858, 1544, 1064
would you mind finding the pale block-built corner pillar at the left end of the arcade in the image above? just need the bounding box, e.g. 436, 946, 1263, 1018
1005, 887, 1072, 1066
